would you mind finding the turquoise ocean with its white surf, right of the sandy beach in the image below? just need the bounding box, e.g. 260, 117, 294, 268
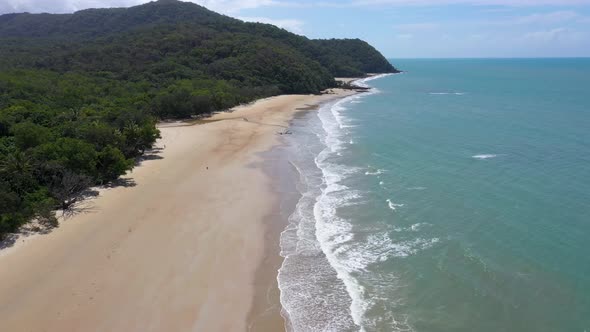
278, 59, 590, 332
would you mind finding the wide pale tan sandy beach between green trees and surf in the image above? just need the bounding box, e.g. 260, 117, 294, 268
0, 90, 355, 331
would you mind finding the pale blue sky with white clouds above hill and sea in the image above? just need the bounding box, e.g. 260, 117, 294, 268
0, 0, 590, 58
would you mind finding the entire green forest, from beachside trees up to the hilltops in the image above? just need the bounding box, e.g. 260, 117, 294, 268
0, 0, 396, 237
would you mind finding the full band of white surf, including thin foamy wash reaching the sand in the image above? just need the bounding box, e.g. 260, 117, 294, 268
278, 73, 428, 332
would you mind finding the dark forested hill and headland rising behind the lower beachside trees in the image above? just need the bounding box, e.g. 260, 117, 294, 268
0, 0, 395, 87
